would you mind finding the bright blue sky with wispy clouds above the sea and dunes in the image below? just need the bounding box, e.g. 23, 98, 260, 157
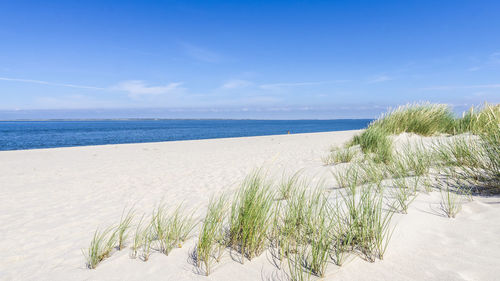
0, 0, 500, 119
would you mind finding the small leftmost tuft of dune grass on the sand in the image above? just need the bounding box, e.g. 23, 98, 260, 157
84, 227, 117, 269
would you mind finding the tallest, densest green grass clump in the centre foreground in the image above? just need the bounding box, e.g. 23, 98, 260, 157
229, 171, 274, 263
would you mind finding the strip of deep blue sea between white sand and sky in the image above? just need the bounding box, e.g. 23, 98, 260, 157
0, 119, 371, 150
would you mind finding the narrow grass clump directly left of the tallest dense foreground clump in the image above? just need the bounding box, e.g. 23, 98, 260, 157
196, 197, 226, 276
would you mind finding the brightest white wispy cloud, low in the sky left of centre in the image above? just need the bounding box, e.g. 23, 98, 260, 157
110, 80, 182, 97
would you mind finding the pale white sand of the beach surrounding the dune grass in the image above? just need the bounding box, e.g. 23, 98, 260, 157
0, 131, 500, 281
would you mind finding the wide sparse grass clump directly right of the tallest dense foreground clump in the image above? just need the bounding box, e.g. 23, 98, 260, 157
273, 181, 333, 280
